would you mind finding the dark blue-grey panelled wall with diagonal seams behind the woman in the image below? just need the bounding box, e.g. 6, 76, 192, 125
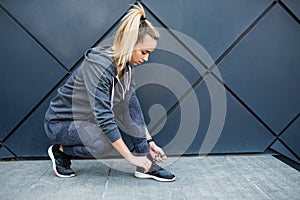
0, 0, 300, 163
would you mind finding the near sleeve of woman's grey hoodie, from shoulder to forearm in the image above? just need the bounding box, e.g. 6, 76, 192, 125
82, 61, 121, 143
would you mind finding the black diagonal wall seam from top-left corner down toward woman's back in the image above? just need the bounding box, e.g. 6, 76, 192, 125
0, 4, 70, 73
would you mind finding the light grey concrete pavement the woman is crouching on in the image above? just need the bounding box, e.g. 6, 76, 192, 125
0, 155, 300, 200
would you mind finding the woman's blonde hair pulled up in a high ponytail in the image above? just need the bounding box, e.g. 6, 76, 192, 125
112, 3, 159, 69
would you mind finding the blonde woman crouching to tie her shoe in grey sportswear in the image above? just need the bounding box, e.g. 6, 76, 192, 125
45, 5, 175, 181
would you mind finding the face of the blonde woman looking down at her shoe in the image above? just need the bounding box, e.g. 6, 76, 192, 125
129, 35, 157, 66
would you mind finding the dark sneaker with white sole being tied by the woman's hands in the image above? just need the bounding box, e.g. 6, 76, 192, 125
134, 162, 176, 182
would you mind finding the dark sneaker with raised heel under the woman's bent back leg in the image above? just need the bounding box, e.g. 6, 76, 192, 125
48, 144, 76, 178
